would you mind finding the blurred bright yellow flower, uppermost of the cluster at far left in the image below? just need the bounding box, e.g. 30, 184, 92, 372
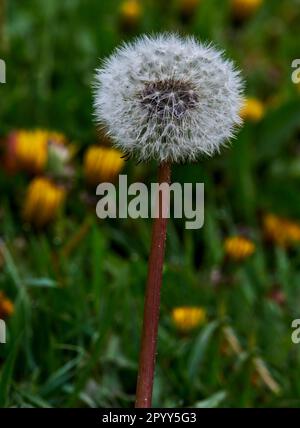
15, 130, 65, 174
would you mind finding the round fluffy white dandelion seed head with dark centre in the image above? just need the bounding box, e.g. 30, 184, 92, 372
94, 34, 243, 162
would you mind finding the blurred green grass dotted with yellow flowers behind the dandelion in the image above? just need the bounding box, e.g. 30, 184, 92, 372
0, 0, 300, 407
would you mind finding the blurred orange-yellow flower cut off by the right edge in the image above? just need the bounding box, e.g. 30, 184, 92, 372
263, 214, 300, 247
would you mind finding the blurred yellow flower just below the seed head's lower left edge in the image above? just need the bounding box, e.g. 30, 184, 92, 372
84, 146, 124, 185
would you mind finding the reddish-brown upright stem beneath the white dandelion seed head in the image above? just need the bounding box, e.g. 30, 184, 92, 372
135, 163, 171, 408
